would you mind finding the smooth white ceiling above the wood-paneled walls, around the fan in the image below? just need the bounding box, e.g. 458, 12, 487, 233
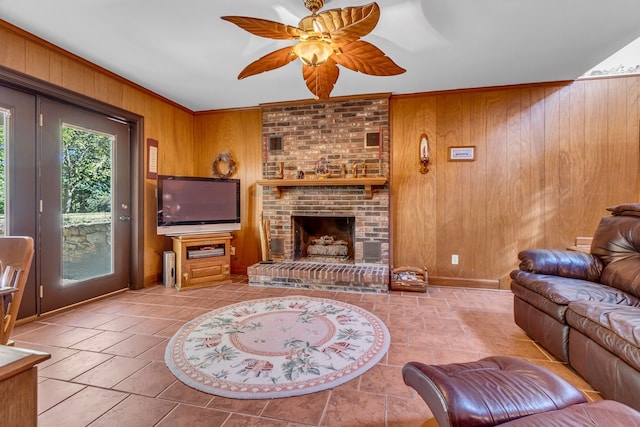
0, 0, 640, 111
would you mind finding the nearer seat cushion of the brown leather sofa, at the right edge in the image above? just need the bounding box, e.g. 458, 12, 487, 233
566, 301, 640, 370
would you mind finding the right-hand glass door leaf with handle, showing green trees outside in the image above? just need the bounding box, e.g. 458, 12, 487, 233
38, 99, 130, 312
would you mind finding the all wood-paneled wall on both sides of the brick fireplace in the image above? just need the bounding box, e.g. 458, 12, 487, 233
0, 21, 640, 287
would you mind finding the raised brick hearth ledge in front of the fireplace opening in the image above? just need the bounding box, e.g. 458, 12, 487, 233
248, 262, 389, 293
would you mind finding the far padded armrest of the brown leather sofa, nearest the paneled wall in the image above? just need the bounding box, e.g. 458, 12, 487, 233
518, 249, 602, 282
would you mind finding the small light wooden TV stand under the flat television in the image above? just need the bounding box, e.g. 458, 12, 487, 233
172, 233, 233, 291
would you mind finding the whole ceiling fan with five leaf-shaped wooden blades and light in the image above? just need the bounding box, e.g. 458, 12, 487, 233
222, 0, 406, 99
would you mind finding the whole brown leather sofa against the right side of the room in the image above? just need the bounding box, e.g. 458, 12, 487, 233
511, 204, 640, 410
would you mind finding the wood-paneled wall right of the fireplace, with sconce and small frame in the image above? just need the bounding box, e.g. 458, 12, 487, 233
391, 77, 640, 287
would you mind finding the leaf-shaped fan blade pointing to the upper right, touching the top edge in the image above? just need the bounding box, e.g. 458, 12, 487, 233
316, 3, 380, 43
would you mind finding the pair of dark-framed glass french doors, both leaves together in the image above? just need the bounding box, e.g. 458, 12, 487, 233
0, 86, 130, 318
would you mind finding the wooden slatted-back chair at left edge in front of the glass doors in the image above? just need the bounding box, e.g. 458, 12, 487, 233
0, 236, 34, 345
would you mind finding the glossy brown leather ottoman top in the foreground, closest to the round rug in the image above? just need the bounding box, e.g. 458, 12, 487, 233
402, 356, 586, 427
